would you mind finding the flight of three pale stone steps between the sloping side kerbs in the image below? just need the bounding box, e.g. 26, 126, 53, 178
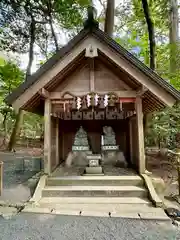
40, 176, 150, 204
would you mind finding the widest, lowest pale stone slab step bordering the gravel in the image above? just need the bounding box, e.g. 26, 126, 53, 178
23, 203, 170, 220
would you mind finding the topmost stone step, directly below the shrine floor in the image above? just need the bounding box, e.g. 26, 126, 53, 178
46, 175, 144, 186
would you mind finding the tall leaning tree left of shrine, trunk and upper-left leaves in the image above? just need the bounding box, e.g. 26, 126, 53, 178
0, 0, 89, 150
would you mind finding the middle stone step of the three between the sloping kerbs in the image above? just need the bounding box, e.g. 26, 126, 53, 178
42, 186, 147, 197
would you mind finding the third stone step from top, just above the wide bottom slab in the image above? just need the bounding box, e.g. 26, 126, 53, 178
39, 197, 152, 204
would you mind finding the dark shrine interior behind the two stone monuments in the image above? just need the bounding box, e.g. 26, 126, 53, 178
59, 118, 130, 165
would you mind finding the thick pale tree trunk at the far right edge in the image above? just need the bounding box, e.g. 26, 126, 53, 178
169, 0, 179, 73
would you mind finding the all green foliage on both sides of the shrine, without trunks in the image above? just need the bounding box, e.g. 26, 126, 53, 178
0, 0, 180, 148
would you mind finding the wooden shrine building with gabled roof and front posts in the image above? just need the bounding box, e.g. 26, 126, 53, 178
6, 14, 180, 174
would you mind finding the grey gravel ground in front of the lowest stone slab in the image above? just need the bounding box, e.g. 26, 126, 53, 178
0, 213, 180, 240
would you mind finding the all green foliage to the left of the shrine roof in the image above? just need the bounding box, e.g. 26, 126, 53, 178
0, 0, 90, 144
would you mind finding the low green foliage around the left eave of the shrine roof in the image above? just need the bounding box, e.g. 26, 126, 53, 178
0, 59, 42, 139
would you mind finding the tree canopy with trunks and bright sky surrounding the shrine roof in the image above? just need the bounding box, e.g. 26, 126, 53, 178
0, 0, 180, 147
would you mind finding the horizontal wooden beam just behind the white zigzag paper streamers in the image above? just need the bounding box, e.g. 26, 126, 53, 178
49, 91, 137, 100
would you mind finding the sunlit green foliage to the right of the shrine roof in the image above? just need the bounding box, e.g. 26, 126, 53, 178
115, 0, 180, 148
